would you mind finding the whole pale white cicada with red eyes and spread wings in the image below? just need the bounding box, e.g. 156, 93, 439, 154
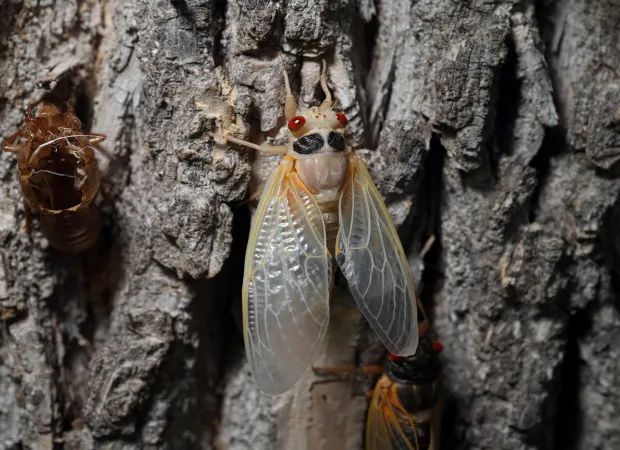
216, 59, 418, 395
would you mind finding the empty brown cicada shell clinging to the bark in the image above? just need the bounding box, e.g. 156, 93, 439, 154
3, 101, 105, 253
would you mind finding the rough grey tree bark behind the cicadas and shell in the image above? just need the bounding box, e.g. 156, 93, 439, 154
0, 0, 620, 450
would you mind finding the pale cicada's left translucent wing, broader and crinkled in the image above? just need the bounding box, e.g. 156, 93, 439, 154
243, 158, 331, 395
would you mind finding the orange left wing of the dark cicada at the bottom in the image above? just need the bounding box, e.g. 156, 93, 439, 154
366, 376, 418, 450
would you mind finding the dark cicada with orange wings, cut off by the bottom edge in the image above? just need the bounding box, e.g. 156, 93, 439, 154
366, 333, 443, 450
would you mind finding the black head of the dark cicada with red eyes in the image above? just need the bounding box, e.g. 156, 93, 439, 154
386, 333, 442, 384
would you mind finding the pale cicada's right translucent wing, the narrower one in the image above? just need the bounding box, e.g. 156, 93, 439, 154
336, 156, 418, 356
